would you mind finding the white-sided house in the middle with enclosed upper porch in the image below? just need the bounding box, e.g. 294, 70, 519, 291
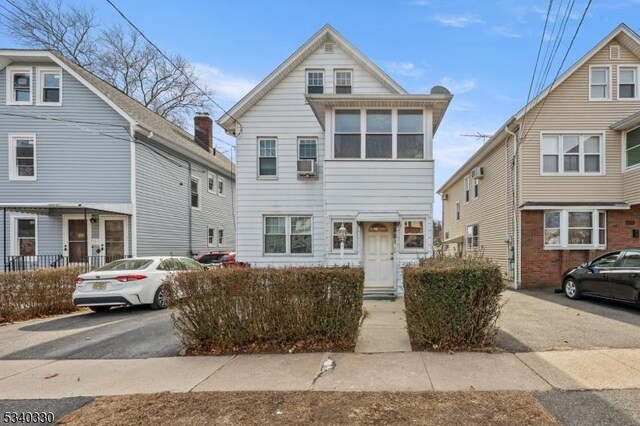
218, 25, 452, 295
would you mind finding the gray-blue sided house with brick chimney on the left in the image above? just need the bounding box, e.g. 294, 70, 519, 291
0, 50, 235, 271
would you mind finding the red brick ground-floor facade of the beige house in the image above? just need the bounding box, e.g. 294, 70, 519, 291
520, 205, 640, 288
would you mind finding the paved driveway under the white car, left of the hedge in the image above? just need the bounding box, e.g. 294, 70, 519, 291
0, 306, 182, 359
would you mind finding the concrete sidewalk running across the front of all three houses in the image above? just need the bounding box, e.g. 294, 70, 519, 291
0, 349, 640, 399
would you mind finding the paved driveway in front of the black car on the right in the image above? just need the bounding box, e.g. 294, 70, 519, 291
497, 289, 640, 352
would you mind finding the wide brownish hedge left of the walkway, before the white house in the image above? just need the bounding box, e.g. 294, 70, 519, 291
165, 267, 364, 354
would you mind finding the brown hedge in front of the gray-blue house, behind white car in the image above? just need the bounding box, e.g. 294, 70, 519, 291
0, 268, 80, 323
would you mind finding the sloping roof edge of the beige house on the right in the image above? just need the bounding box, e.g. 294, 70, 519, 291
437, 24, 640, 194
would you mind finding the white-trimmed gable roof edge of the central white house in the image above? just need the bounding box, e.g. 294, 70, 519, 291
217, 24, 407, 134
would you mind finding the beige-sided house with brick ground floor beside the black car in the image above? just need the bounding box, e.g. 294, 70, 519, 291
438, 24, 640, 288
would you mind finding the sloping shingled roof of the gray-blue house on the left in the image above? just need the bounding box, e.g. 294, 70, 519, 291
0, 49, 233, 174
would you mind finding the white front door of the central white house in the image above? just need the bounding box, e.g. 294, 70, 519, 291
363, 223, 394, 290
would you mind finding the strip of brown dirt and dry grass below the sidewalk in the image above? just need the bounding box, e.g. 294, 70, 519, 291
61, 391, 559, 426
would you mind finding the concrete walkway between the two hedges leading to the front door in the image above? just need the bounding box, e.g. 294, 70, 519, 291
356, 298, 411, 353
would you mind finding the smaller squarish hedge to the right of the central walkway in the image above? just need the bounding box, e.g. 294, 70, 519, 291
404, 258, 506, 350
